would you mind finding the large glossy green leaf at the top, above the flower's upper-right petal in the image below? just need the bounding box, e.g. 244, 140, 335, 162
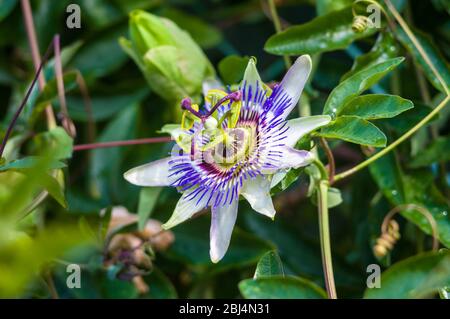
264, 7, 376, 55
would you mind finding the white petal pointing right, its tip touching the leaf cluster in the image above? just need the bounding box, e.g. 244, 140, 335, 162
284, 115, 331, 147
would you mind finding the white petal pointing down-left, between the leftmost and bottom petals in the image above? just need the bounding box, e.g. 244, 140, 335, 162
162, 190, 209, 229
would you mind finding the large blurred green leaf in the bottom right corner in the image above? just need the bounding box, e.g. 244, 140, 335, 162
364, 250, 450, 299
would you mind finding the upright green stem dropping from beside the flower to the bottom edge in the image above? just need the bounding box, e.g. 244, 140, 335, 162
313, 159, 337, 299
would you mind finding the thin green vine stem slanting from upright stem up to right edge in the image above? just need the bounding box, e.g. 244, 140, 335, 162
334, 96, 450, 182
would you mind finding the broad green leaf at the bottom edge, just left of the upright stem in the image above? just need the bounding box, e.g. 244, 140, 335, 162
239, 276, 326, 299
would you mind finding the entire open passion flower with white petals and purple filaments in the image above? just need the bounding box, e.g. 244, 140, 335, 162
124, 55, 331, 262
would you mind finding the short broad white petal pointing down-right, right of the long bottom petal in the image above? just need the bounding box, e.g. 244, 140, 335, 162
241, 176, 275, 219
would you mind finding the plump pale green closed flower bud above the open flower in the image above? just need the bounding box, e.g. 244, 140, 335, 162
120, 10, 215, 112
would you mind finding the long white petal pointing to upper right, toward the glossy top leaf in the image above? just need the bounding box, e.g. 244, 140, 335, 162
274, 55, 312, 118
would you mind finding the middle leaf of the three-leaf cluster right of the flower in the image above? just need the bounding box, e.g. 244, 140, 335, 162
338, 94, 414, 120
